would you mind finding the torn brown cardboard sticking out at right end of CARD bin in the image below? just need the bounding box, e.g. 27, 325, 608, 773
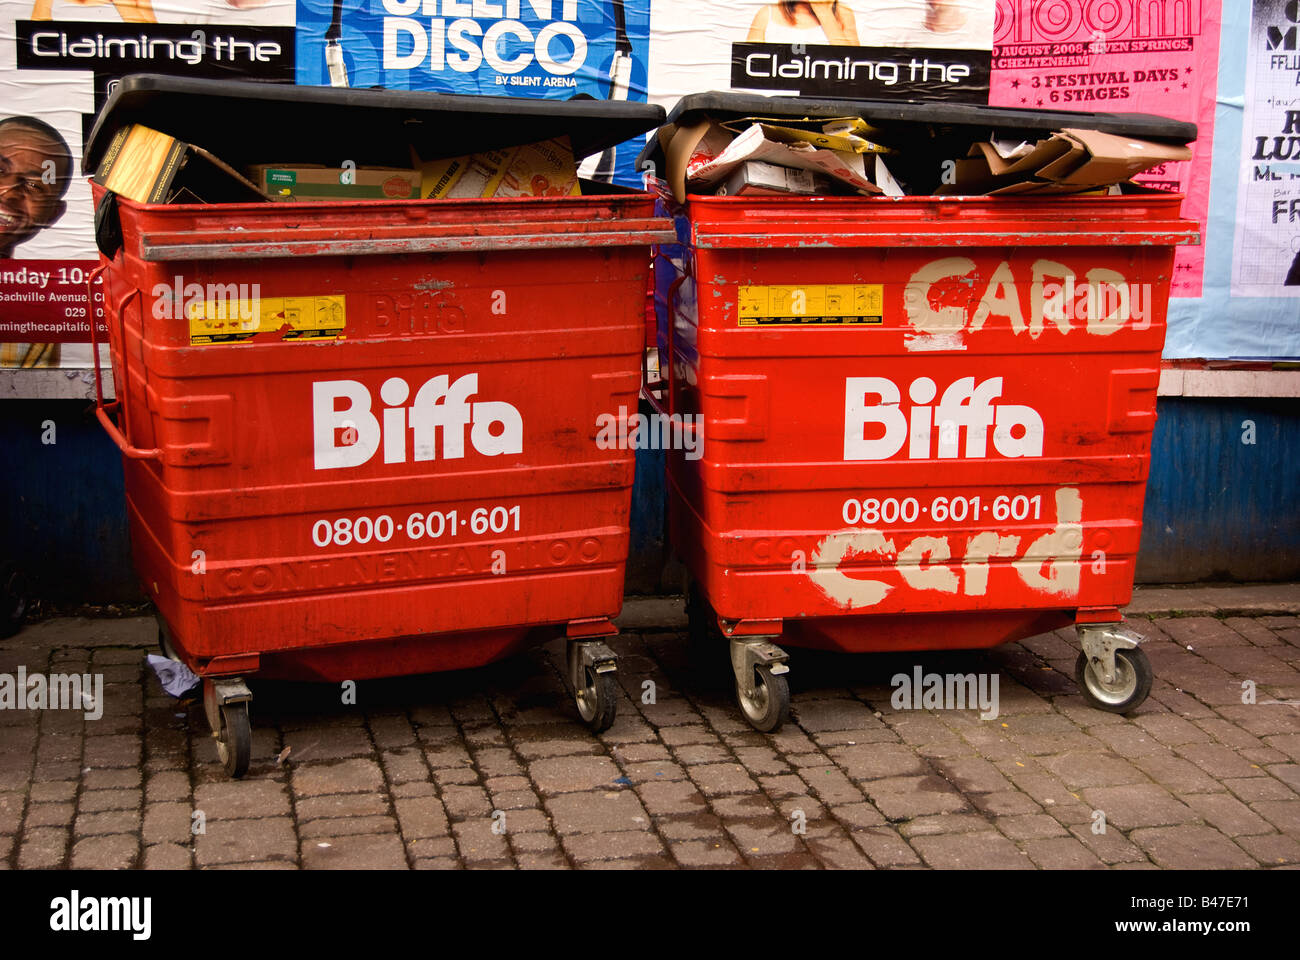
937, 129, 1192, 195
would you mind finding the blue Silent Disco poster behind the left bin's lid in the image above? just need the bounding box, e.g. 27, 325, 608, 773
296, 0, 650, 186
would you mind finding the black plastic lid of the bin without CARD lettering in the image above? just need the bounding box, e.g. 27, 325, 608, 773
82, 74, 664, 173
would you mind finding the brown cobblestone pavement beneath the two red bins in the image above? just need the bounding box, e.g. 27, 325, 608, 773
0, 591, 1300, 869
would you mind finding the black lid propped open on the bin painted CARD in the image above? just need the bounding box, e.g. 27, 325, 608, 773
637, 90, 1196, 179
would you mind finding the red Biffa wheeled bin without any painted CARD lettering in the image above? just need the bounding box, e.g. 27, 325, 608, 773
86, 77, 671, 775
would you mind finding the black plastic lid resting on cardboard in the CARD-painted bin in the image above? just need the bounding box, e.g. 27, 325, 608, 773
655, 90, 1196, 143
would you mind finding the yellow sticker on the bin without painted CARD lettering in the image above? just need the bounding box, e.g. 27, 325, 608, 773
186, 297, 347, 345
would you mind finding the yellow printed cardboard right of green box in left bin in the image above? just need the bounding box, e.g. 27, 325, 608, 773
420, 137, 582, 200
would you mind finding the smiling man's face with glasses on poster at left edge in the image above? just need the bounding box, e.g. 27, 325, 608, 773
0, 121, 72, 256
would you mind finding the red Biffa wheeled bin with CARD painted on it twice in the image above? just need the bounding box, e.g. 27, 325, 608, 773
642, 94, 1197, 730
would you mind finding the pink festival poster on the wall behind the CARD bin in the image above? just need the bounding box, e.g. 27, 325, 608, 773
989, 0, 1219, 297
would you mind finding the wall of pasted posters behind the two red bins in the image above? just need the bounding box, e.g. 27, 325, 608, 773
0, 0, 1300, 367
